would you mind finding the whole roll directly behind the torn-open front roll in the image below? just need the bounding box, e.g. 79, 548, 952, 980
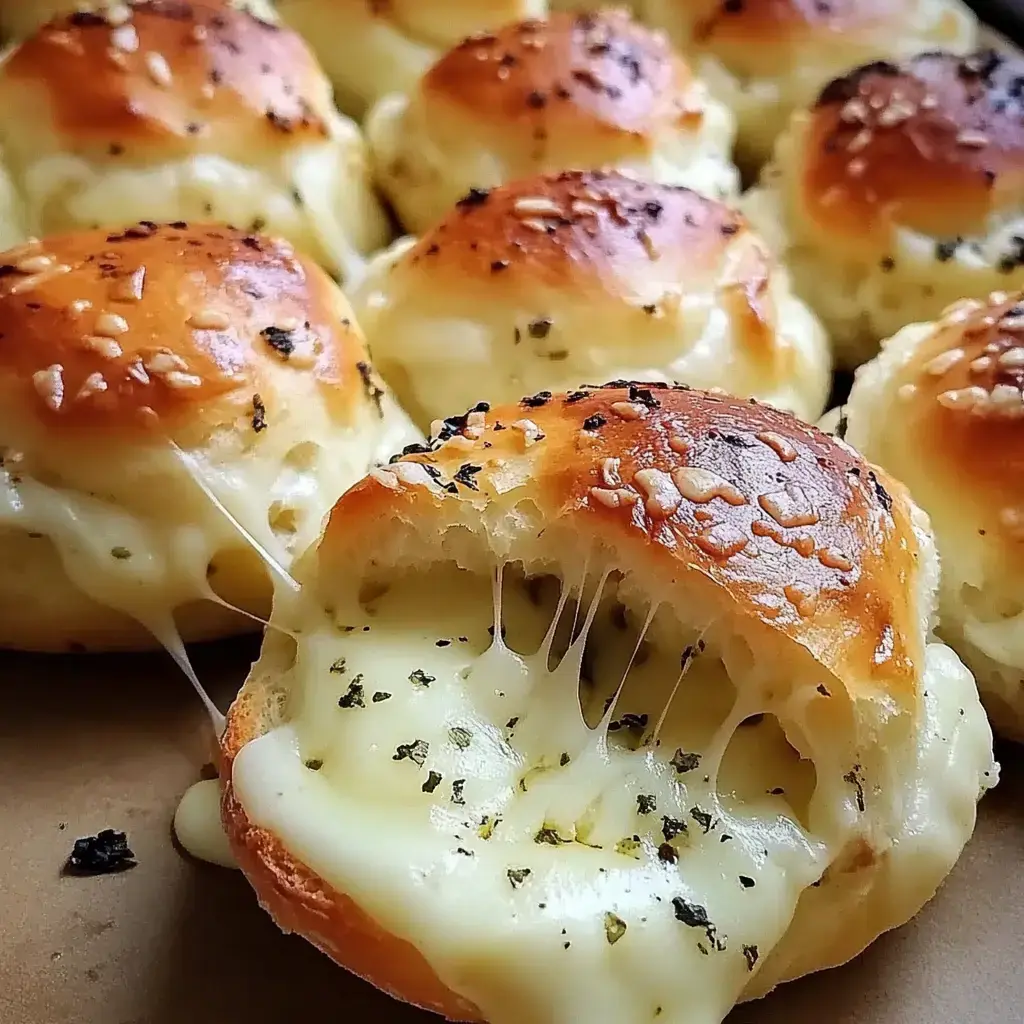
352, 171, 830, 428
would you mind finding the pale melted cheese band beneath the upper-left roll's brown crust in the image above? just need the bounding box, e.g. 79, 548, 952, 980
1, 116, 387, 280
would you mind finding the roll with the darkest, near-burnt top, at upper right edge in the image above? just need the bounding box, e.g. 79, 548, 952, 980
743, 50, 1024, 366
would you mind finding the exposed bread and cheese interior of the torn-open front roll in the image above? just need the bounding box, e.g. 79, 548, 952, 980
225, 516, 994, 1024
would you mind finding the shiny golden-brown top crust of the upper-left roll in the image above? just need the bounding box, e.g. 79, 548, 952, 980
0, 0, 331, 160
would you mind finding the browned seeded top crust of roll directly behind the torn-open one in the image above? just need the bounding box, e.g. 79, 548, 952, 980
407, 171, 749, 295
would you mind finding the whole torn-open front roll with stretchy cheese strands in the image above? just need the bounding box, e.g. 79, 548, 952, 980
221, 385, 996, 1024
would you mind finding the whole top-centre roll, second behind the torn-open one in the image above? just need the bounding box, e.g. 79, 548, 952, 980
366, 9, 737, 231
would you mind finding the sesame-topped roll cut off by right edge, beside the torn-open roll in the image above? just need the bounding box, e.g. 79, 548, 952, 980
846, 292, 1024, 739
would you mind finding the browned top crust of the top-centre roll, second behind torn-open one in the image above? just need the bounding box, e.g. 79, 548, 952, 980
421, 10, 702, 140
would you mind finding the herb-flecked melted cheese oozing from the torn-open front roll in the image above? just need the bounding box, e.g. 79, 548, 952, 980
222, 567, 991, 1024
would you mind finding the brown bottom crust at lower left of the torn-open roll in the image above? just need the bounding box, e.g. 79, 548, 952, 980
220, 683, 482, 1021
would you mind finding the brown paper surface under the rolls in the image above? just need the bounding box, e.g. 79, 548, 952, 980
0, 641, 1024, 1024
